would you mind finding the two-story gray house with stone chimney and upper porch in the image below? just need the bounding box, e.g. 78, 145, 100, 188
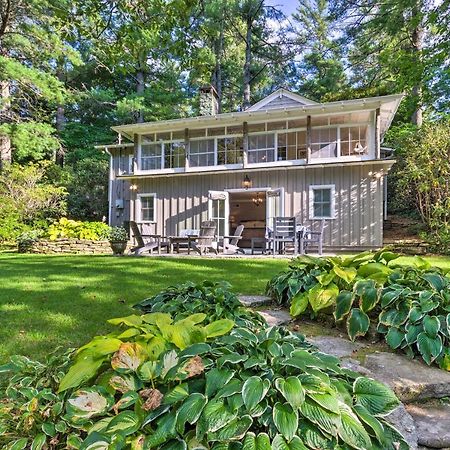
99, 88, 402, 250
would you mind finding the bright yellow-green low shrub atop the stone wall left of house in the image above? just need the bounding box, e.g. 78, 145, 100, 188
46, 217, 110, 241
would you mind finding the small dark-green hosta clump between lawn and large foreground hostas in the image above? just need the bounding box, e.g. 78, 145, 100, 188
134, 281, 266, 328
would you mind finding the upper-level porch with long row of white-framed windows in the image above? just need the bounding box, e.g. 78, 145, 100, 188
100, 95, 401, 177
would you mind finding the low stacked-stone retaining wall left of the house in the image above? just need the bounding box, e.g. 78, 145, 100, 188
19, 239, 112, 254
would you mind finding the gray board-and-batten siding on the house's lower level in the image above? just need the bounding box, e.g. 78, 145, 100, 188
111, 162, 384, 249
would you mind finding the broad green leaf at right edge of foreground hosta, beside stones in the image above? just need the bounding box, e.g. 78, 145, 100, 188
353, 377, 400, 415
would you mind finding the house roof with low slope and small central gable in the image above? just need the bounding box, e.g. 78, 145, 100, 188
112, 89, 404, 140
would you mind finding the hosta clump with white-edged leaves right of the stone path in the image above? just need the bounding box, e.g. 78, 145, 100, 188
267, 251, 450, 370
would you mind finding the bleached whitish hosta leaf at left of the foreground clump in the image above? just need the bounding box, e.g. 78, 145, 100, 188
67, 387, 114, 421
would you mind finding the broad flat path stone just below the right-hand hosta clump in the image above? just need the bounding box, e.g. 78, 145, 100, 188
362, 352, 450, 402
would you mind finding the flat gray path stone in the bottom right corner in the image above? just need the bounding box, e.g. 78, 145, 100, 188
406, 404, 450, 449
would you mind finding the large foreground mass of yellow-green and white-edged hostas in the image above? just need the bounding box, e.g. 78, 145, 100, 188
0, 313, 408, 450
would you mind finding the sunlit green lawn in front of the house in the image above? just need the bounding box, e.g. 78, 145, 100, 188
0, 253, 450, 364
